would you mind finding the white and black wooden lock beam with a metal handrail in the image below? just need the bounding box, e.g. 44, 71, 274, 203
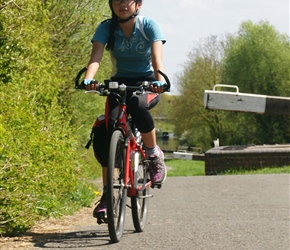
204, 84, 290, 115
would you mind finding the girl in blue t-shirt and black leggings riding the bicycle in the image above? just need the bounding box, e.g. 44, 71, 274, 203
84, 0, 166, 217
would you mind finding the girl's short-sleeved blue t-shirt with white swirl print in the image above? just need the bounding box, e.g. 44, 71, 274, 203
92, 16, 166, 78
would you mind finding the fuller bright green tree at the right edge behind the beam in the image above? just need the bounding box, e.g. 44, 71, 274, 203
223, 21, 290, 144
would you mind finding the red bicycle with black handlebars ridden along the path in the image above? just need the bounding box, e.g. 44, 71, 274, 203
75, 68, 170, 243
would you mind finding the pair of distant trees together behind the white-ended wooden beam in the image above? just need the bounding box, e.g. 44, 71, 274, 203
173, 21, 290, 149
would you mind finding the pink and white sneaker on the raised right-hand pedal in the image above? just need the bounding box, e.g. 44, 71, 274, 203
149, 147, 166, 184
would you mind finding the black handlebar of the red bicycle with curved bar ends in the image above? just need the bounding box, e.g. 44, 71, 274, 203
75, 67, 171, 92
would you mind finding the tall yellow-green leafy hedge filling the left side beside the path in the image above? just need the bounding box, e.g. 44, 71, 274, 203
0, 0, 106, 234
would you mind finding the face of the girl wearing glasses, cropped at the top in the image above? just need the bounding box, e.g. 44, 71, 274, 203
112, 0, 142, 19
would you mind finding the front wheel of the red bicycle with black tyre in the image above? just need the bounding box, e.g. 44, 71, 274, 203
107, 130, 127, 243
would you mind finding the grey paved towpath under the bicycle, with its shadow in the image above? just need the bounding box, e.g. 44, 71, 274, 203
0, 174, 290, 250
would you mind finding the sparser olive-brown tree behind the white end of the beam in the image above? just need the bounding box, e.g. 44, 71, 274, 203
172, 36, 225, 149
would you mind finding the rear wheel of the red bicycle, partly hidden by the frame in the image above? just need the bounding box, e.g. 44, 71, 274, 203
131, 152, 150, 232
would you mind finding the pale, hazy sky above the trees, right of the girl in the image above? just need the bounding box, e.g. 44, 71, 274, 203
140, 0, 290, 91
